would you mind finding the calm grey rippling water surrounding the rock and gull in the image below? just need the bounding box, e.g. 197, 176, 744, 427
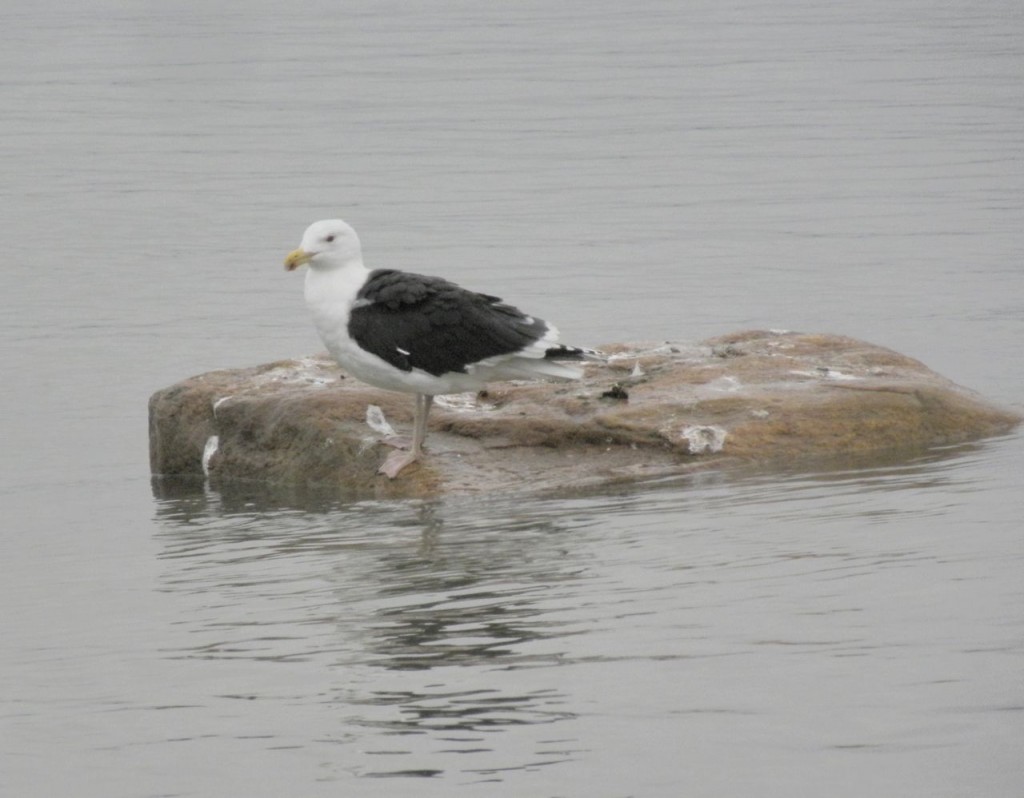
0, 0, 1024, 797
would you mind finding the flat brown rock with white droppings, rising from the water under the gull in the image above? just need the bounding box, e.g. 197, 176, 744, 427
150, 332, 1020, 497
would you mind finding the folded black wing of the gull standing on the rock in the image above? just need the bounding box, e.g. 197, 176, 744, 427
348, 269, 548, 377
